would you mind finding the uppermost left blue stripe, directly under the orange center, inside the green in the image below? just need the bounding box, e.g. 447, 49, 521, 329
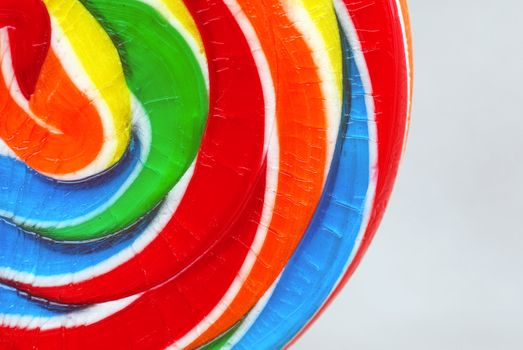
0, 138, 140, 222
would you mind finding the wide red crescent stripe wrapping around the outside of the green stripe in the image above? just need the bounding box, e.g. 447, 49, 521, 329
9, 0, 265, 304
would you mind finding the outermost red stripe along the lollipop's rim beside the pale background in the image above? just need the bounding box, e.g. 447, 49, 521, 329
288, 0, 410, 346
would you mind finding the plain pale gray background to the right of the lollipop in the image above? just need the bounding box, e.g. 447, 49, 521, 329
295, 0, 523, 350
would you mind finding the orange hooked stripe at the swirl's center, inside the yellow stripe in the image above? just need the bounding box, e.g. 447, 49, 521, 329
0, 50, 104, 175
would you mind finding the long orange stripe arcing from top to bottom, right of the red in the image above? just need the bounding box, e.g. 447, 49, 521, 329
186, 0, 327, 348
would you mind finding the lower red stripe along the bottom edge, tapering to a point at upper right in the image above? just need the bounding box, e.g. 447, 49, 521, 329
0, 165, 265, 350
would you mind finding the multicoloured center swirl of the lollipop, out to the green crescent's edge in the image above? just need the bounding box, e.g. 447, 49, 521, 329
0, 0, 208, 241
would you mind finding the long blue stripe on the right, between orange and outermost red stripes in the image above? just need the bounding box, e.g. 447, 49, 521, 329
235, 26, 370, 349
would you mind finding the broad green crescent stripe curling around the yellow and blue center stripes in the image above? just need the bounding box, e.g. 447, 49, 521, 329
40, 0, 209, 240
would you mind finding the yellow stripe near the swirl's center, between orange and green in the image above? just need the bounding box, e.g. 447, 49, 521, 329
44, 0, 131, 166
